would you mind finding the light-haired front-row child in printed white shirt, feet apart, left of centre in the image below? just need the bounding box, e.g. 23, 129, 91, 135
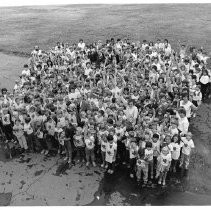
85, 132, 96, 167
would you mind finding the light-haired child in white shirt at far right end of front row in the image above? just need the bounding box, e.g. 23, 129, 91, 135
180, 132, 195, 169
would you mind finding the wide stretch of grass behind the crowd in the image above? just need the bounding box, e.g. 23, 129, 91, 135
0, 4, 211, 53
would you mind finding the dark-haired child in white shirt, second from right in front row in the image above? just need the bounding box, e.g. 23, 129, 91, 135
169, 134, 181, 173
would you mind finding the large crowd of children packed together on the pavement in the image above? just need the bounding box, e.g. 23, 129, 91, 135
0, 38, 211, 185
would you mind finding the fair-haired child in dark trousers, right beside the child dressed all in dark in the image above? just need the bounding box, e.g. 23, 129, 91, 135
73, 127, 85, 162
